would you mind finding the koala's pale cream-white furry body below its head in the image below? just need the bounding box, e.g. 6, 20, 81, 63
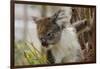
51, 27, 83, 63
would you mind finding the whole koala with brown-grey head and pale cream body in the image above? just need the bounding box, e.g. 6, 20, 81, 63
33, 10, 83, 63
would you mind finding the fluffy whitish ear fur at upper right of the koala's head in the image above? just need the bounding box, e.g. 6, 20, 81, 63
56, 7, 72, 26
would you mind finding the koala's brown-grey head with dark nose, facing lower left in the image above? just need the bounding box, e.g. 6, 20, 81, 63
33, 9, 68, 47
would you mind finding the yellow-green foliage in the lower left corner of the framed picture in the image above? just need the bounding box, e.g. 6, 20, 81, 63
15, 42, 48, 66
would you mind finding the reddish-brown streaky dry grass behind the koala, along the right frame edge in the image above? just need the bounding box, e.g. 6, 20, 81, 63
71, 7, 96, 62
